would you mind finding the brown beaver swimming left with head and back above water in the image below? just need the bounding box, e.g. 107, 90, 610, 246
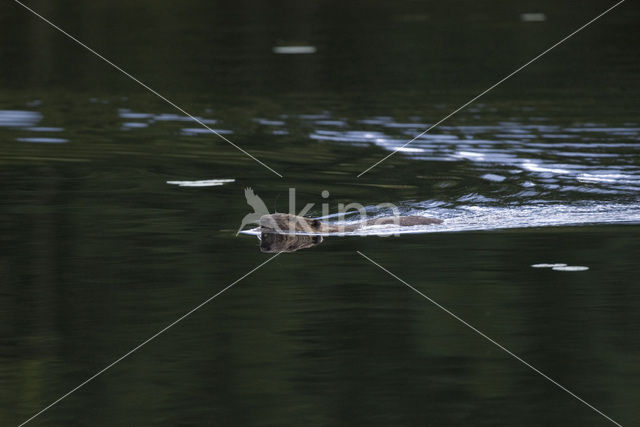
259, 213, 442, 234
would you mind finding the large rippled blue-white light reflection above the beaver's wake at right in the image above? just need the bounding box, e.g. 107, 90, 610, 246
310, 117, 640, 197
